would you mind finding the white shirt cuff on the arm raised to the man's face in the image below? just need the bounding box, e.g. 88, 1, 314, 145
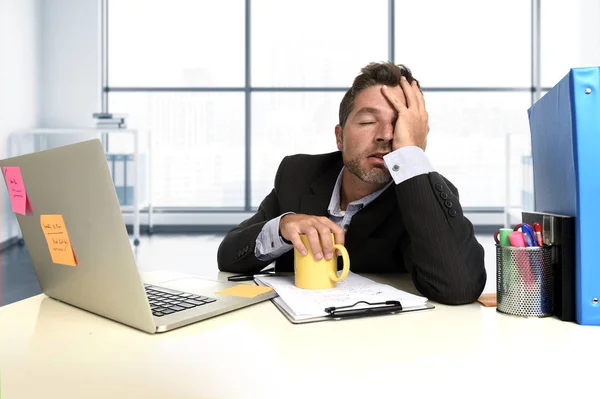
383, 146, 434, 184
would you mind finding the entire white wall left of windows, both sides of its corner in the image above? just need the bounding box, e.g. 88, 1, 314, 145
0, 0, 101, 241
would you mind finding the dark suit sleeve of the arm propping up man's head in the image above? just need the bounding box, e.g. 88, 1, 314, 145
395, 172, 487, 305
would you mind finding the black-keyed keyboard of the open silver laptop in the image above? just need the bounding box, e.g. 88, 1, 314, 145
144, 285, 216, 317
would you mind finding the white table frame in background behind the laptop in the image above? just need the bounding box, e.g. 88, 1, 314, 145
8, 128, 152, 246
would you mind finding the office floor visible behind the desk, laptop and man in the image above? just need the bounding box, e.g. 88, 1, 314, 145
0, 234, 496, 305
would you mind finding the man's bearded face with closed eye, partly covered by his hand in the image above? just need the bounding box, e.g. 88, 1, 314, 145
335, 85, 406, 184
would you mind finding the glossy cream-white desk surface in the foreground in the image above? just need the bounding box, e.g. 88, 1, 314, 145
0, 272, 600, 399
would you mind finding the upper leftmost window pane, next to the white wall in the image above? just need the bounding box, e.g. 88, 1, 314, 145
108, 0, 245, 87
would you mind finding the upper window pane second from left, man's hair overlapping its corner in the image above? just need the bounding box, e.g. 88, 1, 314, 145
251, 0, 388, 87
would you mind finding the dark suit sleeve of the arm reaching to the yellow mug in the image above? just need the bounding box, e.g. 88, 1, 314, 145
217, 162, 283, 273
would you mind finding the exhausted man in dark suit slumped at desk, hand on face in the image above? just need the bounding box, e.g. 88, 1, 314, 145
217, 63, 486, 305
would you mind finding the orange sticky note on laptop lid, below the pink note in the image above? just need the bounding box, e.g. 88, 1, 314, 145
40, 215, 77, 266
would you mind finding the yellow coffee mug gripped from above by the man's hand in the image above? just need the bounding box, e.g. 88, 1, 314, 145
294, 234, 350, 290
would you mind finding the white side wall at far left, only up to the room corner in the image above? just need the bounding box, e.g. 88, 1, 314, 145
0, 0, 41, 241
